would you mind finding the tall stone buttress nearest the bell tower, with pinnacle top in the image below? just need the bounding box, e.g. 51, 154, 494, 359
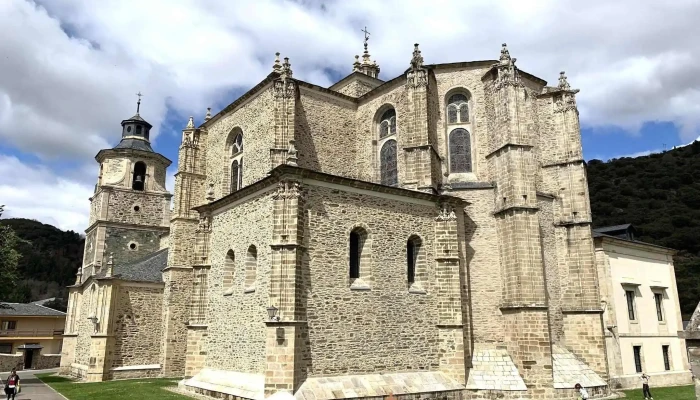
161, 114, 209, 377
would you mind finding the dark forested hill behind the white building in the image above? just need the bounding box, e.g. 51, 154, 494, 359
587, 141, 700, 319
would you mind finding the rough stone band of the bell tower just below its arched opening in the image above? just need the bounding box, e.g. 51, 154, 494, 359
107, 190, 170, 226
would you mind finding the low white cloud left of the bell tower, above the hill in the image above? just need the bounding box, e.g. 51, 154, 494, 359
0, 155, 94, 233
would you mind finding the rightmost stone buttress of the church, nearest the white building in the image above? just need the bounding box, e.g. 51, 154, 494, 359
539, 72, 608, 386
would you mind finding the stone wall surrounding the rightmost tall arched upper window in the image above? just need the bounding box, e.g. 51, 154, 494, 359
435, 67, 491, 181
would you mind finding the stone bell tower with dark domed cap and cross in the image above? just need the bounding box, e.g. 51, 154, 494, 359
81, 97, 172, 281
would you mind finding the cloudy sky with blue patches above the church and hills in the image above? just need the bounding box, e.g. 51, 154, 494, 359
0, 0, 700, 232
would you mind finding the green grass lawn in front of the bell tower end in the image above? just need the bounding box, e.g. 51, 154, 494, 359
36, 374, 192, 400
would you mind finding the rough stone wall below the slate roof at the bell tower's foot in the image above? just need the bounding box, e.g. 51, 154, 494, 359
112, 286, 163, 367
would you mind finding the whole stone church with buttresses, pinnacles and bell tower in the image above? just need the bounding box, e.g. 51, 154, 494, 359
61, 41, 609, 400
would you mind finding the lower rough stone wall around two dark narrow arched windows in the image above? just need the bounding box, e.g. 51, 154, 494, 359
297, 183, 442, 377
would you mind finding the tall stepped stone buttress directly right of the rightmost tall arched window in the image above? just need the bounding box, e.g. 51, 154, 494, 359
483, 45, 553, 398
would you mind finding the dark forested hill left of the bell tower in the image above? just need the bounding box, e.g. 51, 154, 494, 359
0, 218, 85, 301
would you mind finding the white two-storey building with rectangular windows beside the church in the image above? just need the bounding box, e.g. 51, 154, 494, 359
593, 224, 692, 388
